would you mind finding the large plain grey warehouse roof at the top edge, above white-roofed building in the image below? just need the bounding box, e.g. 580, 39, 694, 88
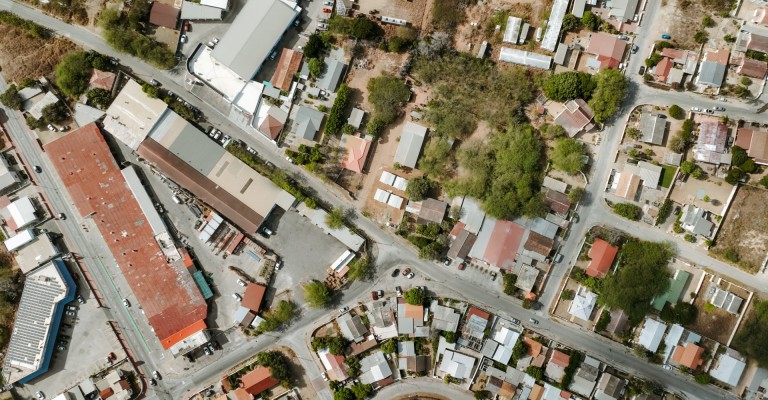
211, 0, 301, 80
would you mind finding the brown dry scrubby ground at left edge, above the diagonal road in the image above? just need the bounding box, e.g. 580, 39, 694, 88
0, 24, 78, 82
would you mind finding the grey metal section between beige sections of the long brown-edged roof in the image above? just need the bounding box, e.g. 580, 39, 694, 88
149, 110, 226, 176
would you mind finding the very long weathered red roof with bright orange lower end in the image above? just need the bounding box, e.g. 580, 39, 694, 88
45, 124, 208, 349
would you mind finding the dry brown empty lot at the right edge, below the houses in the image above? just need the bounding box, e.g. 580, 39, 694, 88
712, 186, 768, 273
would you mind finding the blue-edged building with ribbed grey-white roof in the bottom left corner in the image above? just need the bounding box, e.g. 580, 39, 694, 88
3, 258, 75, 385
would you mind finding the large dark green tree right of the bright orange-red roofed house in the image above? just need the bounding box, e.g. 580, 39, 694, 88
598, 239, 674, 325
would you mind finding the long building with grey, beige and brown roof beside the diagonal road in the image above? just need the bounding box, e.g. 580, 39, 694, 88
137, 110, 296, 234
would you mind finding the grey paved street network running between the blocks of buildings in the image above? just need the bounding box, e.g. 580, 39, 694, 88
0, 0, 768, 399
